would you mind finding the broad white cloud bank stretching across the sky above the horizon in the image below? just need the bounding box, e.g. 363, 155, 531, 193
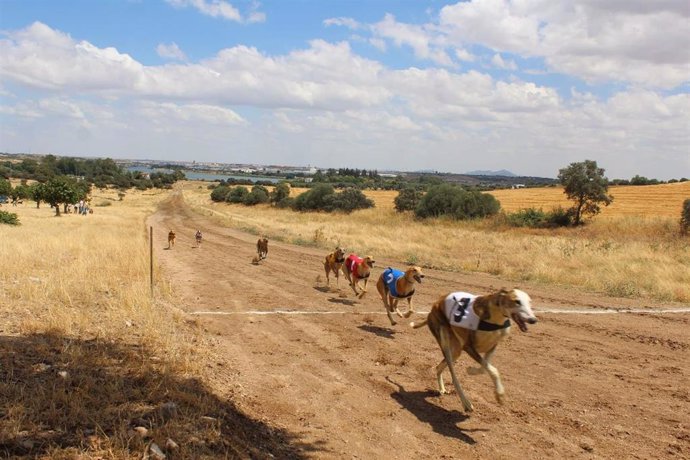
0, 21, 690, 178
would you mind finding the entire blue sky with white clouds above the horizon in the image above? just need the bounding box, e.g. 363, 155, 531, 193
0, 0, 690, 180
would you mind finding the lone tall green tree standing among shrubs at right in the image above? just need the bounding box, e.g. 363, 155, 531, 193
558, 160, 613, 225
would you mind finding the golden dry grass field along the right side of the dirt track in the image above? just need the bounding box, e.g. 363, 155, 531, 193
184, 182, 690, 302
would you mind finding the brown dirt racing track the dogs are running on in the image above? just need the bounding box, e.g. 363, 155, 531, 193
150, 195, 690, 459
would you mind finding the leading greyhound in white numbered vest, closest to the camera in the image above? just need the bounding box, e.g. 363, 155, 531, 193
410, 289, 537, 412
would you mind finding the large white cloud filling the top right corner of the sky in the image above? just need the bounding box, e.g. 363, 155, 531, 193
439, 0, 690, 88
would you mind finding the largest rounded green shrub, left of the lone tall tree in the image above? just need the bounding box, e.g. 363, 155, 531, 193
415, 184, 501, 219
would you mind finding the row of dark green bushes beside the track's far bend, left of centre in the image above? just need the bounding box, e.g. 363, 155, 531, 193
211, 182, 374, 212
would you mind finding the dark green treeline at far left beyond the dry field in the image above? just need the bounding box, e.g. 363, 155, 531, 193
0, 155, 185, 190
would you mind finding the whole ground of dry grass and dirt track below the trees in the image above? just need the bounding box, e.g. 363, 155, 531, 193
0, 182, 690, 459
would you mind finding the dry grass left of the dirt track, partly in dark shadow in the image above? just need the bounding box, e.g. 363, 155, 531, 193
0, 191, 299, 459
